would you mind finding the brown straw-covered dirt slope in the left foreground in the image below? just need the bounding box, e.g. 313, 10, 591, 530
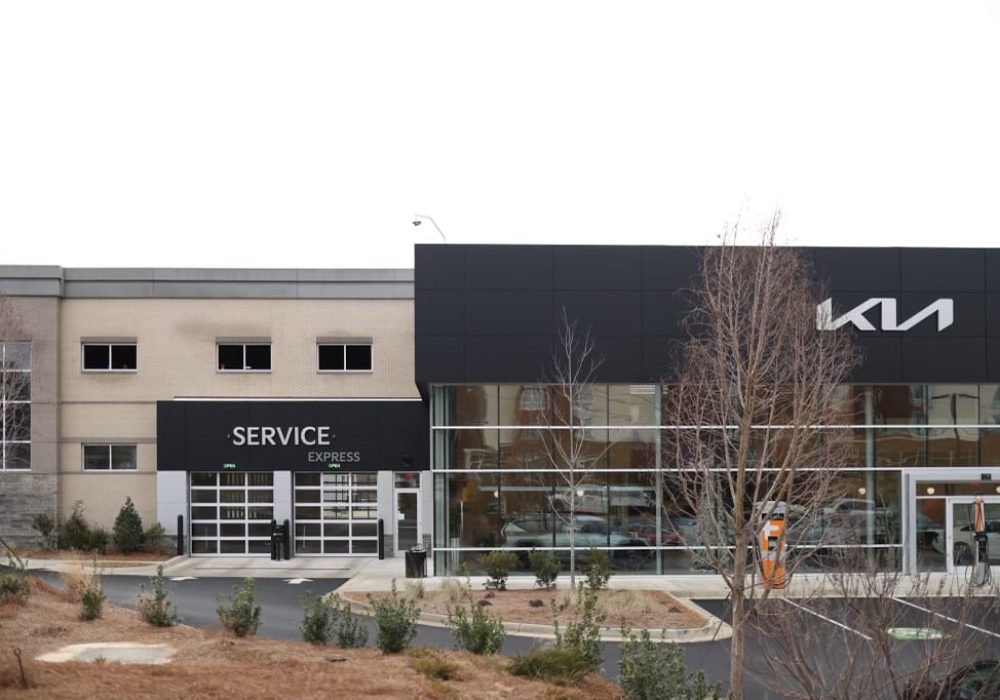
0, 579, 621, 700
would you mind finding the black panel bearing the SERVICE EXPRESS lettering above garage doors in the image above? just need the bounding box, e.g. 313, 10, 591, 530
156, 401, 430, 471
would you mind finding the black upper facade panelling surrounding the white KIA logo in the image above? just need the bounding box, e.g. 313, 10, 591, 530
415, 244, 1000, 384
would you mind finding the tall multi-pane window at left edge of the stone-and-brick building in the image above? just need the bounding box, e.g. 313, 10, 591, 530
0, 342, 31, 469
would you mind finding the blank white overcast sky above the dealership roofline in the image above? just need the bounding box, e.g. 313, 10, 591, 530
0, 0, 1000, 267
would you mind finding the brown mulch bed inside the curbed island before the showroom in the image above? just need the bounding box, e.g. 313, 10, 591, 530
347, 587, 706, 629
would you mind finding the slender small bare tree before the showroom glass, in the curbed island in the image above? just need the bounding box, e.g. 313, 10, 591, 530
538, 309, 611, 588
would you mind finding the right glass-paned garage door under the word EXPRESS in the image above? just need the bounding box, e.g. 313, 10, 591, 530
295, 472, 378, 556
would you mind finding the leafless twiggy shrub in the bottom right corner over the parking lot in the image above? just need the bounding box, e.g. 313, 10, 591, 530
749, 549, 1000, 700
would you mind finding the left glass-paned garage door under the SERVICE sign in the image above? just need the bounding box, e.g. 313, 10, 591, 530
191, 472, 274, 555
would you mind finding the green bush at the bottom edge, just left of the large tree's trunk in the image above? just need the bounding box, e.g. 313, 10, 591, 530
618, 627, 722, 700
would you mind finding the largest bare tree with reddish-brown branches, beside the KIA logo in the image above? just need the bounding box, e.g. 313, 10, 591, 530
663, 214, 857, 698
